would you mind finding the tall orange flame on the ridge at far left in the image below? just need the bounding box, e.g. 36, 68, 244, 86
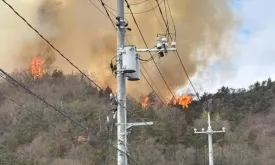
30, 56, 45, 79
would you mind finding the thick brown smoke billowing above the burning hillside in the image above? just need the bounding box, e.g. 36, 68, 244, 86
0, 0, 236, 99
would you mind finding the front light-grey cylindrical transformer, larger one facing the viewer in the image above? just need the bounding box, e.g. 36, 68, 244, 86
122, 45, 136, 73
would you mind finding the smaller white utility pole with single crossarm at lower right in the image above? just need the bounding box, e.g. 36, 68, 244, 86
194, 112, 225, 165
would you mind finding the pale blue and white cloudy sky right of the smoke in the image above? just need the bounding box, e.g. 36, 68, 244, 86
181, 0, 275, 93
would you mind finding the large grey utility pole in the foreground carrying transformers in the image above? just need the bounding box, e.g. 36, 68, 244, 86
116, 0, 176, 165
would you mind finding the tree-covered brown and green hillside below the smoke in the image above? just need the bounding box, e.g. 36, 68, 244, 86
0, 71, 275, 165
